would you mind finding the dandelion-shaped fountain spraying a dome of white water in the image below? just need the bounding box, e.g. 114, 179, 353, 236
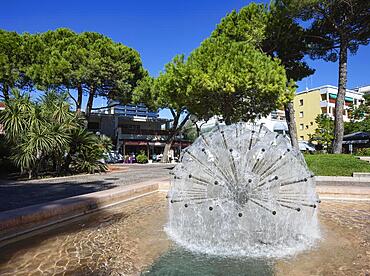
166, 123, 320, 257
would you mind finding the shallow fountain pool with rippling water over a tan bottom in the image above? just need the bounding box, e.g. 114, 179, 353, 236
0, 186, 370, 275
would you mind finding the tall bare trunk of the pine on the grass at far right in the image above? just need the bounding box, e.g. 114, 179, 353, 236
333, 40, 347, 154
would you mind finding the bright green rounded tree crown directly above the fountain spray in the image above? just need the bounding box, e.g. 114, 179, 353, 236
188, 38, 293, 123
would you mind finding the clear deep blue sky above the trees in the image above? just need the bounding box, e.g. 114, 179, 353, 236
0, 0, 370, 116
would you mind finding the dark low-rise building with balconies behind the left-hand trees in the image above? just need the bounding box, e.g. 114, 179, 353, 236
88, 101, 190, 158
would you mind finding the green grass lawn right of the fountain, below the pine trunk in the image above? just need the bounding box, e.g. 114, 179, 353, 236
304, 154, 370, 176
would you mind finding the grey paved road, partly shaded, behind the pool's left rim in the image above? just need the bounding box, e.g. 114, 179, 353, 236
0, 164, 173, 212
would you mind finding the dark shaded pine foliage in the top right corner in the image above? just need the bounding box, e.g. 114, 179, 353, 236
294, 0, 370, 61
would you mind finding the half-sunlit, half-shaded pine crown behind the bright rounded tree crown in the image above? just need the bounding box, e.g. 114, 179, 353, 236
212, 0, 314, 81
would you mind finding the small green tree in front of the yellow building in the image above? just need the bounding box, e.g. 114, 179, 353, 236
309, 114, 334, 150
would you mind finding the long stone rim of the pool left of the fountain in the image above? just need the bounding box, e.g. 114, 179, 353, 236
0, 178, 168, 247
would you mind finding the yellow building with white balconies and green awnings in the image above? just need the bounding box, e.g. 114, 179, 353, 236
293, 85, 363, 141
